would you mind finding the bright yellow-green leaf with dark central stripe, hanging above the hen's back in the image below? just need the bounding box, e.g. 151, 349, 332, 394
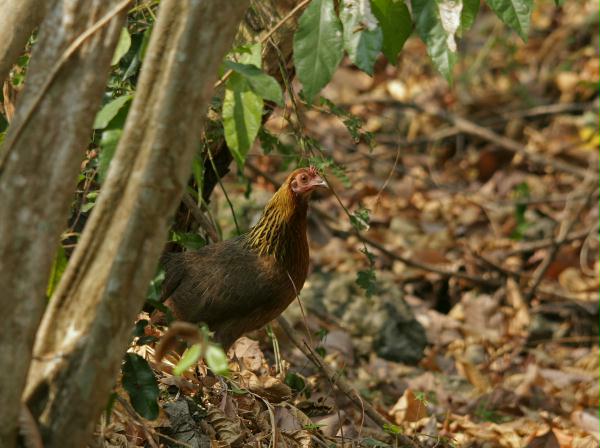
223, 73, 263, 168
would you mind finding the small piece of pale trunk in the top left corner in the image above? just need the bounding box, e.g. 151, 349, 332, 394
0, 0, 48, 85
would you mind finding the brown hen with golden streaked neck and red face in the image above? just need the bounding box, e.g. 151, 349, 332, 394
161, 167, 327, 349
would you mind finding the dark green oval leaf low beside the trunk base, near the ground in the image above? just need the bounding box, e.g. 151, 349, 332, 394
121, 353, 159, 420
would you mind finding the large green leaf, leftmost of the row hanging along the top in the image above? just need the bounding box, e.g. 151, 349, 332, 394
294, 0, 344, 102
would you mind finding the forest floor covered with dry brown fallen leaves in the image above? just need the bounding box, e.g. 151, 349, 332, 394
104, 1, 600, 448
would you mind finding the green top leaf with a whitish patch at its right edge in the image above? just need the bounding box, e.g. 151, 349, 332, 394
411, 0, 456, 81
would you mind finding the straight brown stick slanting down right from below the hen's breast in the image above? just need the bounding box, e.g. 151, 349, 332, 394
277, 316, 417, 447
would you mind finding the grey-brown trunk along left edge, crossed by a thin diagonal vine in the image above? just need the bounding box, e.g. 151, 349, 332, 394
0, 0, 123, 447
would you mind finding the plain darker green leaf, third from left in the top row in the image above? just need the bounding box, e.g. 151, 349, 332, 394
371, 0, 413, 65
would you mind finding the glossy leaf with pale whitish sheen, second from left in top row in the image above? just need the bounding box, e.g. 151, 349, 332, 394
340, 0, 383, 75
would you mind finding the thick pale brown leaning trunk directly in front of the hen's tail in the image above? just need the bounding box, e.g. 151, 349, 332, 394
25, 0, 247, 447
